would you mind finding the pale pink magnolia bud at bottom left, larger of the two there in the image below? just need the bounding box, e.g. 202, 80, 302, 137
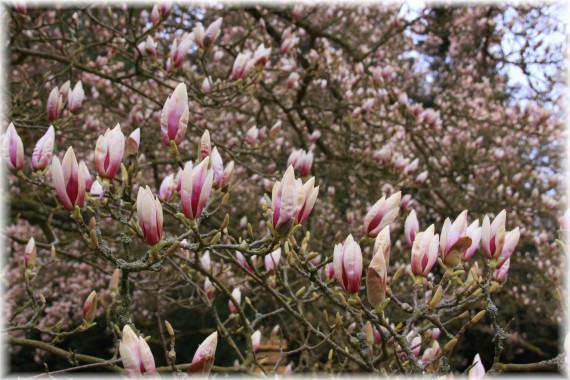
119, 325, 156, 378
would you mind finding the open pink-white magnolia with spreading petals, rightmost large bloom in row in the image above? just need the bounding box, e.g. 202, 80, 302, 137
481, 210, 520, 268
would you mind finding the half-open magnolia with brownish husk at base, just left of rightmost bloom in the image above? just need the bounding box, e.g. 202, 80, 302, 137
439, 210, 471, 268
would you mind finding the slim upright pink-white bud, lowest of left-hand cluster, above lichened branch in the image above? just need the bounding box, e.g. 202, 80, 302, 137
137, 186, 163, 245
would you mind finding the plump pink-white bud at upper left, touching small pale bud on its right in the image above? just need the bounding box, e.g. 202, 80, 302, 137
95, 124, 125, 180
